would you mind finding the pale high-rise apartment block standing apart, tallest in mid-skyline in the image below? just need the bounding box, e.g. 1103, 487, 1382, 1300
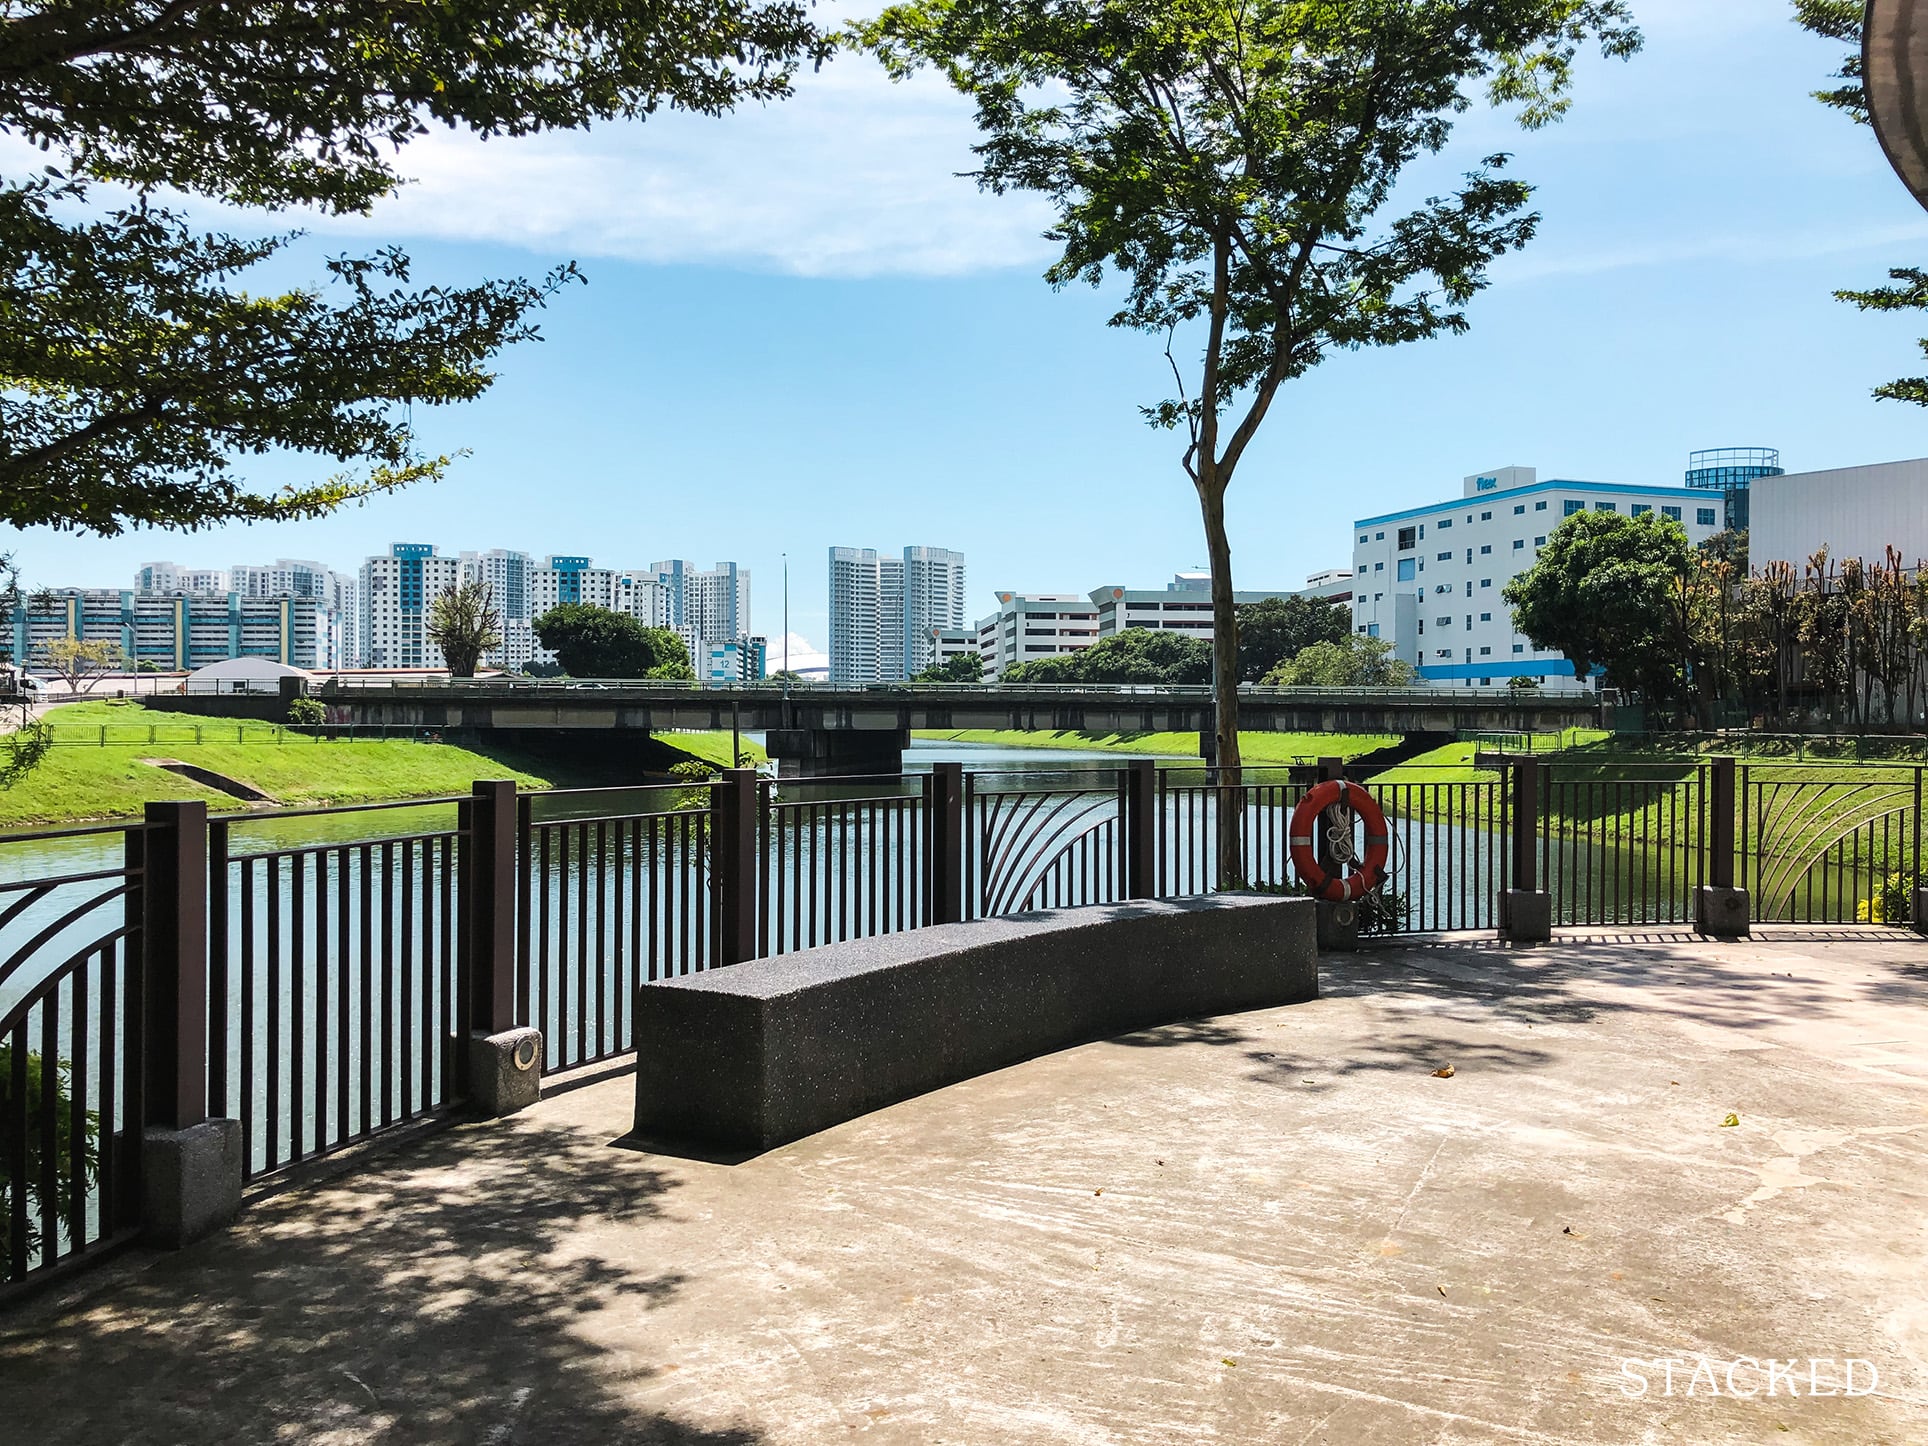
829, 548, 966, 683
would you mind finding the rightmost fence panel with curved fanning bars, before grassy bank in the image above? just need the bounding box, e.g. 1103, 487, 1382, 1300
1737, 765, 1922, 924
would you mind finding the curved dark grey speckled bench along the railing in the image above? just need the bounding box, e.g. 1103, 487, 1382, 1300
636, 895, 1319, 1149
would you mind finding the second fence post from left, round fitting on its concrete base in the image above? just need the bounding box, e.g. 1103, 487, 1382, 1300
455, 779, 542, 1116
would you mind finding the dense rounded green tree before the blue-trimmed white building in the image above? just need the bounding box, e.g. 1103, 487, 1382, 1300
1502, 513, 1691, 692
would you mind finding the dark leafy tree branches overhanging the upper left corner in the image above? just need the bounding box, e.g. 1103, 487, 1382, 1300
0, 0, 829, 534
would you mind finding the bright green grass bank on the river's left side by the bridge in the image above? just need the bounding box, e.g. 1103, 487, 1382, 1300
0, 700, 762, 827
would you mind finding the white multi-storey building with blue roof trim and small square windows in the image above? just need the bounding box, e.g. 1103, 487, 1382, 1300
1352, 467, 1727, 688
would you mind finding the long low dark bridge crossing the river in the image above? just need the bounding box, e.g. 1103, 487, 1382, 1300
296, 677, 1612, 777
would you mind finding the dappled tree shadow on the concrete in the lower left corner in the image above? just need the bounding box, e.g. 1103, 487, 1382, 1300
0, 1124, 763, 1446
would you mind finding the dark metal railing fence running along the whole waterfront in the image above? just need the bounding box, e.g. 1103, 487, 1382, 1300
0, 756, 1922, 1284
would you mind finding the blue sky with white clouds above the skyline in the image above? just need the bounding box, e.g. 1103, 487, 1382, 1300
0, 0, 1928, 646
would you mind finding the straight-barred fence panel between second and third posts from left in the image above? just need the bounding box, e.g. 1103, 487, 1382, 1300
517, 785, 715, 1070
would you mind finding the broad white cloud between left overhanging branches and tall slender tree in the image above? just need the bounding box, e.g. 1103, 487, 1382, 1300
308, 58, 1051, 276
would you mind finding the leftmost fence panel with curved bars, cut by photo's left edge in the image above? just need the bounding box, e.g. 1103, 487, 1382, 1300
0, 823, 145, 1290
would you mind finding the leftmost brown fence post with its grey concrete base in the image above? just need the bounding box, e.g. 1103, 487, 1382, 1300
141, 802, 243, 1249
